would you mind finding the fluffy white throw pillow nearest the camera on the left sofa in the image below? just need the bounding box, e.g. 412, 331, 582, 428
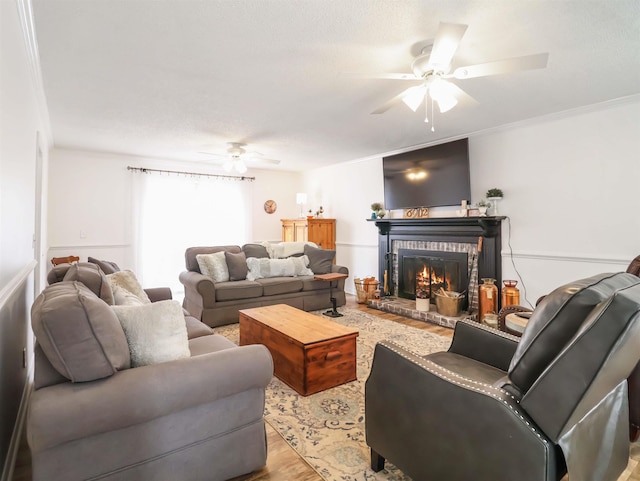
112, 301, 191, 367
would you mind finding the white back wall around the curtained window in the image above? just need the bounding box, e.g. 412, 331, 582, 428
49, 149, 301, 270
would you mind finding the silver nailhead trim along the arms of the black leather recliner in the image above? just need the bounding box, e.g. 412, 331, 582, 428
380, 340, 548, 444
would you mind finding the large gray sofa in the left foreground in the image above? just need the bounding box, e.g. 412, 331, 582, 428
27, 266, 273, 481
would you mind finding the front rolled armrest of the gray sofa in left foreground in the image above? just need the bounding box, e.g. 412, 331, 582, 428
28, 345, 273, 451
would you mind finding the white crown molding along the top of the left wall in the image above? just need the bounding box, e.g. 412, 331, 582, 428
15, 0, 53, 150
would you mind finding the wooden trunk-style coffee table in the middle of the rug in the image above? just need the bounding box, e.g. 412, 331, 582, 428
240, 304, 358, 396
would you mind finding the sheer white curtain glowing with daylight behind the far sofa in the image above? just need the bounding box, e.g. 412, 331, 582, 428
132, 171, 252, 301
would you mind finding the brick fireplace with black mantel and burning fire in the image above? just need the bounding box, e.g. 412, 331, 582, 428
371, 217, 505, 325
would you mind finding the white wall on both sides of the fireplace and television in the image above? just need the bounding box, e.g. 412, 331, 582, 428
304, 97, 640, 302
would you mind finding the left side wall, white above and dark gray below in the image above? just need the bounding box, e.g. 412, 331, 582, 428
0, 1, 48, 472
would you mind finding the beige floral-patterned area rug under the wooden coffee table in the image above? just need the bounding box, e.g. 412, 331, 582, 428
215, 308, 451, 481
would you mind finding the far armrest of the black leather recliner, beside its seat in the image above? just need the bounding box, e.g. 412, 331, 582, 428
449, 320, 520, 371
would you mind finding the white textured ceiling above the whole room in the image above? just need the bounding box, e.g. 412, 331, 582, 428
33, 0, 640, 170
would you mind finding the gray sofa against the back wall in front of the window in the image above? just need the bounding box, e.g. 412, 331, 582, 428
180, 244, 349, 327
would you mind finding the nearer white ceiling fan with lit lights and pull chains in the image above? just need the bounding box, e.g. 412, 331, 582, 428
360, 22, 549, 131
